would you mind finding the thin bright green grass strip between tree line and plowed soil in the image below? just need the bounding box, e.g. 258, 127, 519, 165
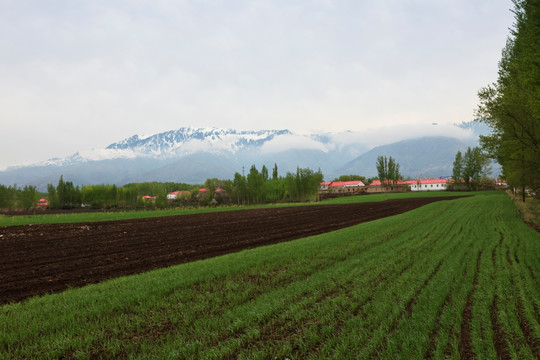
0, 192, 470, 226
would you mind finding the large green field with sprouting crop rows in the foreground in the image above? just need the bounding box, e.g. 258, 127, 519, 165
0, 192, 540, 359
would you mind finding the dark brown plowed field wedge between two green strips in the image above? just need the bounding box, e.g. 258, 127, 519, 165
0, 197, 460, 304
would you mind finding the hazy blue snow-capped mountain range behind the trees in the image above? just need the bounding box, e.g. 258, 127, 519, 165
0, 123, 485, 190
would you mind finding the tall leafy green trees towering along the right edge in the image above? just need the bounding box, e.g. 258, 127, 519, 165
477, 0, 540, 200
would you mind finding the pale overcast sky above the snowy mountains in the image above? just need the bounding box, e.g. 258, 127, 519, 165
0, 0, 514, 169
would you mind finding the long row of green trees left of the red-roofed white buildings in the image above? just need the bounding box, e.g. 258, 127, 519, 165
0, 165, 323, 209
